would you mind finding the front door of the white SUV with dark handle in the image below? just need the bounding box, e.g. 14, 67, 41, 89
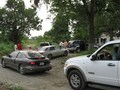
87, 43, 119, 86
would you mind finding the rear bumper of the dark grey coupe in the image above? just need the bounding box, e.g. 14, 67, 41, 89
24, 65, 52, 73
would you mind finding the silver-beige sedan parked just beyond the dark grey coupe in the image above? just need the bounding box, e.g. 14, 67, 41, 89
39, 45, 68, 59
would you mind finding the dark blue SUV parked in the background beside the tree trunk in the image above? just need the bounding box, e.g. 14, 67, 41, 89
68, 40, 86, 53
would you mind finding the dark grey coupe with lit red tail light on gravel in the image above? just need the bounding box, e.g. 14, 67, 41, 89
1, 50, 52, 74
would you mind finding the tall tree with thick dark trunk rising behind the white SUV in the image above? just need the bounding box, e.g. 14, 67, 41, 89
34, 0, 120, 50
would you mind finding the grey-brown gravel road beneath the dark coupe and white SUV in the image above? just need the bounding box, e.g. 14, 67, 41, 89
0, 54, 101, 90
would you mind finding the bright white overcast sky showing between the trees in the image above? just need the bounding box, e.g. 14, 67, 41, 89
0, 0, 52, 37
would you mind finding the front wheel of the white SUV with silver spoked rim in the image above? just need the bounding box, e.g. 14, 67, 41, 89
68, 70, 86, 90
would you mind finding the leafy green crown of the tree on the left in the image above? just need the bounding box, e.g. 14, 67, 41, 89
2, 0, 42, 43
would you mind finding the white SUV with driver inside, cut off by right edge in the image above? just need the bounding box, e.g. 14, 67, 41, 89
64, 40, 120, 90
